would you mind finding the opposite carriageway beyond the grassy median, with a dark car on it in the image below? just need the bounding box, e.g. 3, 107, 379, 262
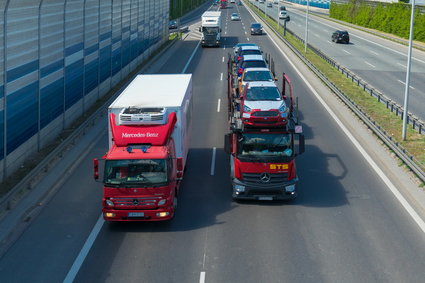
250, 0, 425, 121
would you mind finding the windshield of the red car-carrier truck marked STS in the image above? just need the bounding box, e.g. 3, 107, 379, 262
238, 133, 293, 161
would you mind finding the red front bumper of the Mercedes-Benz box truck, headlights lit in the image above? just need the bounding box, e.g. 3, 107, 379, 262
102, 206, 174, 221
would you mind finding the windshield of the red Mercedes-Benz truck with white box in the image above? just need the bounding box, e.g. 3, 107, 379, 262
104, 159, 168, 188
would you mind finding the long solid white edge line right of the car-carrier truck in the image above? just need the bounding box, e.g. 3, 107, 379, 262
269, 22, 425, 234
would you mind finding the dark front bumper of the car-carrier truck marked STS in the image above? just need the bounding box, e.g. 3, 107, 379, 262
232, 178, 298, 200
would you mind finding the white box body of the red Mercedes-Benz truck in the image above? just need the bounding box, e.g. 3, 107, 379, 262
108, 74, 193, 168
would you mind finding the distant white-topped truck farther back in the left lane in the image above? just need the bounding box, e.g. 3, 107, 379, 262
199, 11, 221, 47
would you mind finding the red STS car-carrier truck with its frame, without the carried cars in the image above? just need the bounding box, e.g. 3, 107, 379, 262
224, 62, 304, 200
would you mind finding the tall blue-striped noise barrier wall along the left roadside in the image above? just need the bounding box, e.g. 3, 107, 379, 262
0, 0, 169, 181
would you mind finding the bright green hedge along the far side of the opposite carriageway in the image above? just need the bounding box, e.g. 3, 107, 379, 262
329, 0, 425, 42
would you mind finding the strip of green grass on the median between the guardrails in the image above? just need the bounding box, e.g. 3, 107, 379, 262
245, 2, 425, 178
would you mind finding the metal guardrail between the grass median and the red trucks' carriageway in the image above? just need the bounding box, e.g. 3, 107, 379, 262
245, 0, 425, 183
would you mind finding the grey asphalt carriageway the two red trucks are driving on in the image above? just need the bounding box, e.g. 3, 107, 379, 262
0, 1, 425, 283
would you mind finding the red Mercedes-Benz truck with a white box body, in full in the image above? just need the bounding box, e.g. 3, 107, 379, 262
94, 74, 193, 221
